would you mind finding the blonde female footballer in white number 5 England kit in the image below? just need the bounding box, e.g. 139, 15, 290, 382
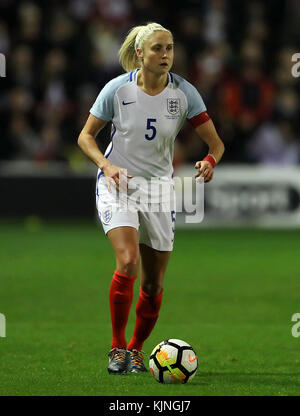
78, 23, 224, 374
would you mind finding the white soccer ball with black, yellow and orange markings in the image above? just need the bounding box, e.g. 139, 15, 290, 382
149, 339, 198, 384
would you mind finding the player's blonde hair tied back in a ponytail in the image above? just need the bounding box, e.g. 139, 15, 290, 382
119, 23, 172, 72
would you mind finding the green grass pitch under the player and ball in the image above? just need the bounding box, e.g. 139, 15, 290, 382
0, 220, 300, 396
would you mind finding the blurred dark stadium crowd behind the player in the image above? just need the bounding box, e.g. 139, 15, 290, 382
0, 0, 300, 169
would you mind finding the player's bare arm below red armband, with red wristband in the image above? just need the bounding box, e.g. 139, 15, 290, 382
195, 119, 225, 182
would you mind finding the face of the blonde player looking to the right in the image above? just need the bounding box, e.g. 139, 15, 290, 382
140, 31, 174, 75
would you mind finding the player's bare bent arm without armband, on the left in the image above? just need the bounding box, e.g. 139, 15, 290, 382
77, 114, 129, 190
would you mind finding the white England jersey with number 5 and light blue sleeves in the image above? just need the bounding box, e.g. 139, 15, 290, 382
90, 69, 209, 180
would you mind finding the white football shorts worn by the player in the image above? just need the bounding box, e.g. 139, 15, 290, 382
96, 175, 176, 251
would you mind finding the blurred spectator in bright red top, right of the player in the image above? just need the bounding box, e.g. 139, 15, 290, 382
219, 40, 275, 162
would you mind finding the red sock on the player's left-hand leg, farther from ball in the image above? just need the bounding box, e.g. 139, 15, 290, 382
109, 270, 136, 349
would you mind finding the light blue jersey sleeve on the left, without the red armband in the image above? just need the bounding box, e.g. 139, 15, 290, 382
90, 74, 129, 121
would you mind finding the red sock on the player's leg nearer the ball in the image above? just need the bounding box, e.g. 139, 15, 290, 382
127, 288, 163, 351
